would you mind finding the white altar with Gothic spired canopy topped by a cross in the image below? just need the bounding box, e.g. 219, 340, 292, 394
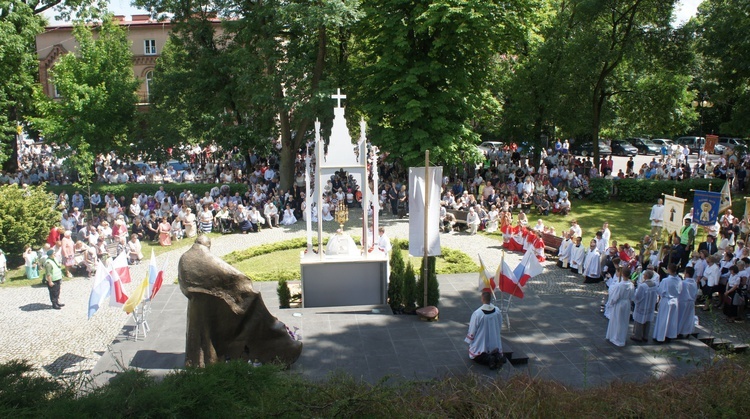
300, 92, 388, 307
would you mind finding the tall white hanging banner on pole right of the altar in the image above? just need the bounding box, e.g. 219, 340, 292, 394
409, 166, 443, 257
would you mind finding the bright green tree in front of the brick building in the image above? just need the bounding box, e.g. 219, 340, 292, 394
32, 16, 139, 182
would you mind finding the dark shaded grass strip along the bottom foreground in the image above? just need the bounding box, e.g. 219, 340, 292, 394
0, 356, 750, 418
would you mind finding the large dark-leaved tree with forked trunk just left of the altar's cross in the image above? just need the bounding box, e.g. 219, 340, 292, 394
140, 0, 358, 188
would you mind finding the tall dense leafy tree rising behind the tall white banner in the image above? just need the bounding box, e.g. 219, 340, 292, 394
354, 0, 527, 169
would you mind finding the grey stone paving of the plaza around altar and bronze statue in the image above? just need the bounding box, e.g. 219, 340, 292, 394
0, 217, 750, 387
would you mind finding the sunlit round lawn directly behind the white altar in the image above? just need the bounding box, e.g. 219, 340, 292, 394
231, 238, 479, 281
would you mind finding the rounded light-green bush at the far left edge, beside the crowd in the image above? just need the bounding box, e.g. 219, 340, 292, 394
0, 185, 60, 264
